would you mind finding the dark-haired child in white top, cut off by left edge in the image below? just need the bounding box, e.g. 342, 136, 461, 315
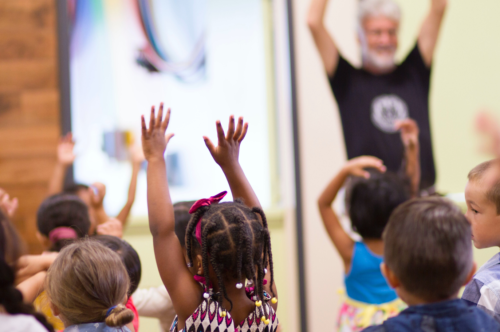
0, 209, 54, 332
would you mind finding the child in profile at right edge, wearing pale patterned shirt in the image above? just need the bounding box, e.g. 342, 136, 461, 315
462, 159, 500, 322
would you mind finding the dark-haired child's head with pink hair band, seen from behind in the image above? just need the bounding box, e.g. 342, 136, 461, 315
37, 194, 90, 251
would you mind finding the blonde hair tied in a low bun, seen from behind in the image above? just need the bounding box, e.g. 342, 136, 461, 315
45, 240, 134, 327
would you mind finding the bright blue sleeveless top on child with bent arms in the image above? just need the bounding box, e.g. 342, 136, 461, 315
344, 242, 398, 304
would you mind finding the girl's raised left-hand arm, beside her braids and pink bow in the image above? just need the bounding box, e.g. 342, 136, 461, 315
141, 104, 202, 322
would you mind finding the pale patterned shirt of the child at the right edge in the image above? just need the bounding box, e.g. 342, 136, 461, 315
462, 253, 500, 322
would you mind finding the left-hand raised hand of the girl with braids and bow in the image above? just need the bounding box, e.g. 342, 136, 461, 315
141, 103, 174, 161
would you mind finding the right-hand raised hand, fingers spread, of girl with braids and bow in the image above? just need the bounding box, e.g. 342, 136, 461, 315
203, 115, 248, 169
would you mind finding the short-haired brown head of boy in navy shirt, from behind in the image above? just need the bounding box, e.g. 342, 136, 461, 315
382, 197, 475, 305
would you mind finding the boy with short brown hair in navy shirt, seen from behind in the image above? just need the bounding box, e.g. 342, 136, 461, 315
364, 197, 500, 332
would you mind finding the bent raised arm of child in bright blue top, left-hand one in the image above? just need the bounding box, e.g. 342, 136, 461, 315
318, 157, 385, 271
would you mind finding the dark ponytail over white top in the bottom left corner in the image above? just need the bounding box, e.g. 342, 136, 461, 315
0, 257, 54, 332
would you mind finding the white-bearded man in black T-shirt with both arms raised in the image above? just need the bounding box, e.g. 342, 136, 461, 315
308, 0, 446, 192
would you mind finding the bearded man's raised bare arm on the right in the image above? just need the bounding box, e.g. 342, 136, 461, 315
418, 0, 447, 67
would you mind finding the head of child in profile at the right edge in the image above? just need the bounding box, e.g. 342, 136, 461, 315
465, 159, 500, 249
